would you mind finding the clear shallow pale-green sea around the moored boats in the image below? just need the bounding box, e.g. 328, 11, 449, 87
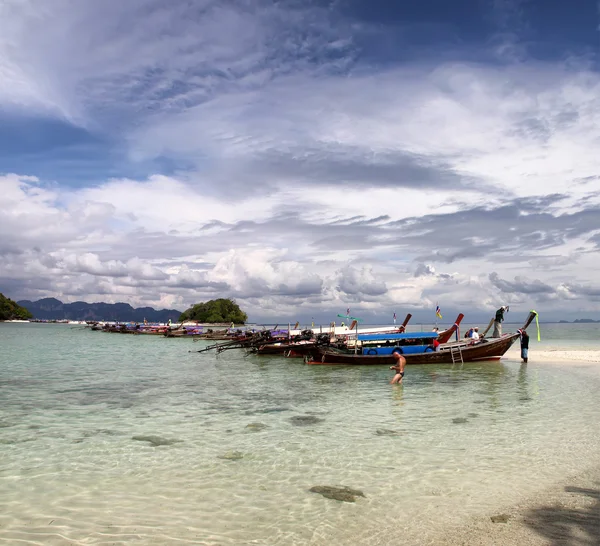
0, 323, 600, 546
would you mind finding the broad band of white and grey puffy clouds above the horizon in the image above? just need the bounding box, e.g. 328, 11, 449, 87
0, 170, 597, 320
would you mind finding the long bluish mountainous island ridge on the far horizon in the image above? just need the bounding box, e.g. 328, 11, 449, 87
17, 298, 181, 322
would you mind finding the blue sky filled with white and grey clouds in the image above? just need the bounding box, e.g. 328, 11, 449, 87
0, 0, 600, 323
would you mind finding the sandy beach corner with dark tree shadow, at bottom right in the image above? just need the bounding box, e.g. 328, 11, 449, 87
431, 466, 600, 546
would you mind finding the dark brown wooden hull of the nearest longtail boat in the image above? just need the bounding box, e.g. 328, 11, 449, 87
307, 334, 519, 366
